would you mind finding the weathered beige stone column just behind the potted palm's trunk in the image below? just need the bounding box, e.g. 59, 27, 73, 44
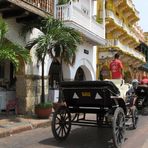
16, 75, 48, 114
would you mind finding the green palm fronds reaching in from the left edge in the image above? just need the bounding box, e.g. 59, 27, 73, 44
0, 17, 30, 70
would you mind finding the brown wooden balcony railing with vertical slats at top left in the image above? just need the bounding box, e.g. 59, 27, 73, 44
22, 0, 54, 15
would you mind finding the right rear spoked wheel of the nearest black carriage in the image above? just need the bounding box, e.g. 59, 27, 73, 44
112, 107, 125, 148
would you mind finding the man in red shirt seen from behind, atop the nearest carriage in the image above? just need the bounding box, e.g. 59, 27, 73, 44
110, 53, 123, 79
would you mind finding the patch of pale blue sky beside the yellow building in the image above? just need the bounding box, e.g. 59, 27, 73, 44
133, 0, 148, 32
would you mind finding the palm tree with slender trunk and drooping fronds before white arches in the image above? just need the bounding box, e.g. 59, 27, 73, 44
27, 17, 82, 103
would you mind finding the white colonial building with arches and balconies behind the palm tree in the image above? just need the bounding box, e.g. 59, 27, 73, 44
0, 0, 106, 113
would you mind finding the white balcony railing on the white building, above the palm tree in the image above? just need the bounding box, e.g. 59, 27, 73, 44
56, 3, 105, 44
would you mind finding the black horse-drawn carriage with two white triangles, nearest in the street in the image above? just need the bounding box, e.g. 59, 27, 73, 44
52, 81, 137, 147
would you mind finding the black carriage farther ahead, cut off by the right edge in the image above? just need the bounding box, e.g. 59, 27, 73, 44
136, 85, 148, 114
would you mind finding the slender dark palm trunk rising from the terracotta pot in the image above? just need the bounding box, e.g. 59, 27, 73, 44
41, 59, 45, 103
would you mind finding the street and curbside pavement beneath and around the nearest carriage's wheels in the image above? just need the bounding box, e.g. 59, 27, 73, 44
0, 115, 148, 148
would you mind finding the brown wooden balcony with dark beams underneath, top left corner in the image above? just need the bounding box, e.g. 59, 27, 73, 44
0, 0, 54, 19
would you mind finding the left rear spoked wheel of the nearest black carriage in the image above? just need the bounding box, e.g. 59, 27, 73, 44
51, 106, 71, 141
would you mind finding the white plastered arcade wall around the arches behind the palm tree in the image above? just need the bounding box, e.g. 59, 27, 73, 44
3, 19, 96, 80
